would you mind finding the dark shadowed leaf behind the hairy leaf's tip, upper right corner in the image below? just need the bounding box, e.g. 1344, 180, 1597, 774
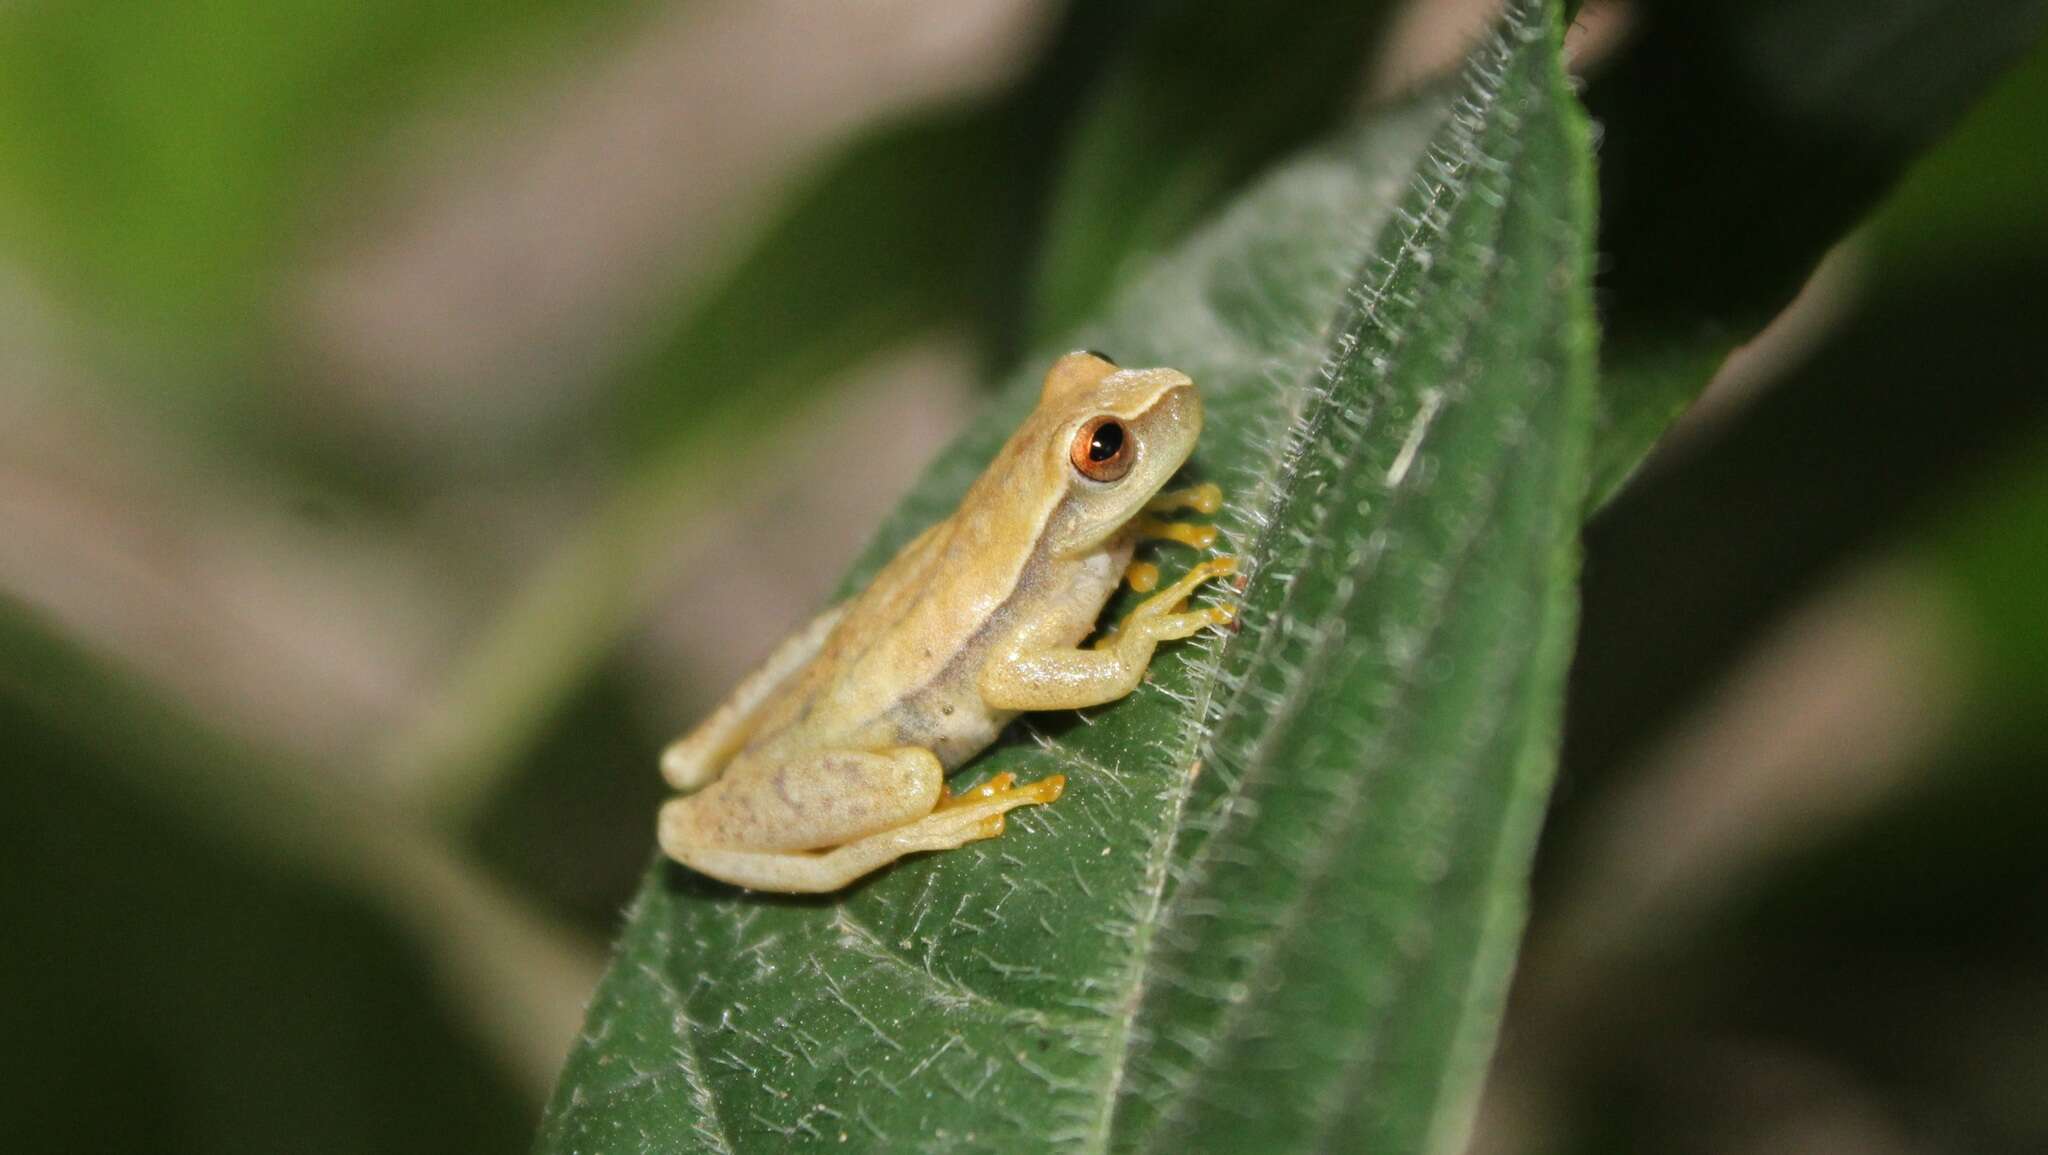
1587, 0, 2048, 504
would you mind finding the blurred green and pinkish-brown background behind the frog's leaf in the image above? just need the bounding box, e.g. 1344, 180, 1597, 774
0, 0, 2048, 1153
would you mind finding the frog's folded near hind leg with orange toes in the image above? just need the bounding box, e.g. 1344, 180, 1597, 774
659, 745, 1063, 893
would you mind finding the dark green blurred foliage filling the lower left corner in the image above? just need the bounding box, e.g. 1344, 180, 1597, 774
0, 602, 530, 1155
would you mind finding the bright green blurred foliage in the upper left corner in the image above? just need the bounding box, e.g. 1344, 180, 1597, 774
0, 0, 616, 350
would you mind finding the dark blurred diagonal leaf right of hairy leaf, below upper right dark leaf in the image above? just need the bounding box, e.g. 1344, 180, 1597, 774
1561, 260, 2048, 798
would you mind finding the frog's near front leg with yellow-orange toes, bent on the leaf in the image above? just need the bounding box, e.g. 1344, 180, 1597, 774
981, 557, 1237, 711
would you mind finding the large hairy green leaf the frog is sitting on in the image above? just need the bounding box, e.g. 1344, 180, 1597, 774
539, 2, 1593, 1151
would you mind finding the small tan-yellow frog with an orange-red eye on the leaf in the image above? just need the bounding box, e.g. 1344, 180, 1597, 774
657, 350, 1239, 893
